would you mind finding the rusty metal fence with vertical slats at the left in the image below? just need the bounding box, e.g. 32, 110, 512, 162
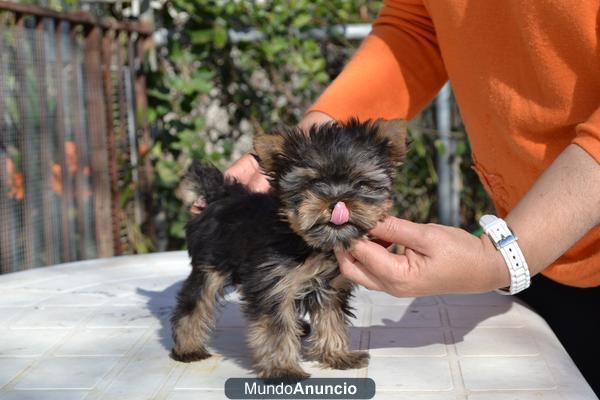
0, 1, 152, 273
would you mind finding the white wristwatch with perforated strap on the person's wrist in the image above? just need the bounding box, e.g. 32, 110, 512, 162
479, 215, 531, 295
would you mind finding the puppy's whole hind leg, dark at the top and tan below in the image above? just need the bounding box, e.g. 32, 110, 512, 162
171, 267, 226, 362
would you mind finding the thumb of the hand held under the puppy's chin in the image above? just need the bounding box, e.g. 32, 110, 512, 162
369, 216, 427, 252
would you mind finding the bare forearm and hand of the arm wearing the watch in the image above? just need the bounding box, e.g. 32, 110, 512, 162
336, 144, 600, 297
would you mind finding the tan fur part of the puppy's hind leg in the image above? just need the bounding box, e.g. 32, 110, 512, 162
173, 270, 225, 356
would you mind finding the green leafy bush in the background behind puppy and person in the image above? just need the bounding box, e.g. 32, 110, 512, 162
148, 0, 485, 249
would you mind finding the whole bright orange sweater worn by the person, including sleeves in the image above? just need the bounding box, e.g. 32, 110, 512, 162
311, 0, 600, 287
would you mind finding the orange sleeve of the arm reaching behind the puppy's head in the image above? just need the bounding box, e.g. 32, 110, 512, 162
308, 0, 447, 120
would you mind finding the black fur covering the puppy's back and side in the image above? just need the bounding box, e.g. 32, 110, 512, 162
186, 164, 314, 318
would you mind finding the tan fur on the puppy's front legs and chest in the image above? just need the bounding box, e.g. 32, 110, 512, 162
248, 254, 368, 377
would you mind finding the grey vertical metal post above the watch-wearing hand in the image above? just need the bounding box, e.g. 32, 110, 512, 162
435, 82, 460, 226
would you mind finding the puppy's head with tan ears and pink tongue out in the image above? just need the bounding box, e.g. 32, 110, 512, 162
254, 119, 406, 250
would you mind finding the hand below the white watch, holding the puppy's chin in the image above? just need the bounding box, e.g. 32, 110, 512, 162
336, 217, 510, 297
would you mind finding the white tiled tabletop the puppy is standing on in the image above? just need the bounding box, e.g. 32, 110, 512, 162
0, 252, 596, 400
